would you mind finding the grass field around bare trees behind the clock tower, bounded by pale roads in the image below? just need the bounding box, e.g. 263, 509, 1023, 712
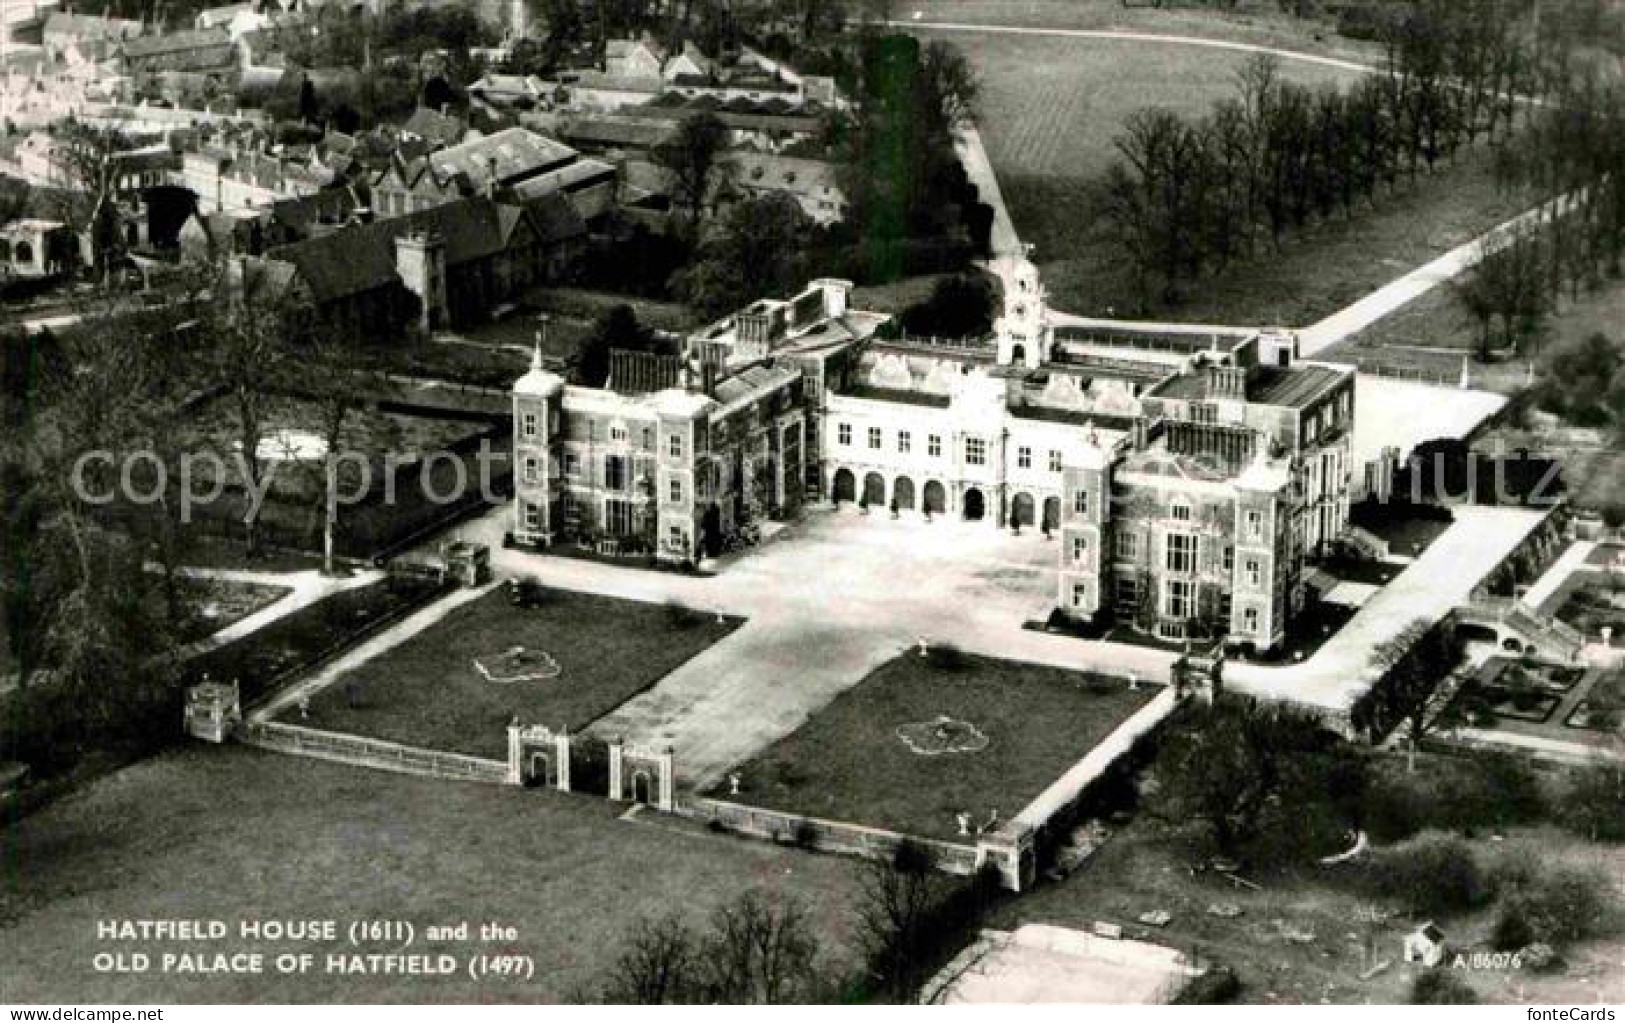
936, 31, 1532, 326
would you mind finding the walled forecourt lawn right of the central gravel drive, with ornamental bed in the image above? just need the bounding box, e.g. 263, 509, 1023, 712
723, 653, 1155, 840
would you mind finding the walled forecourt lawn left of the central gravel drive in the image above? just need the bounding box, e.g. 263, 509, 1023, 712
294, 588, 739, 758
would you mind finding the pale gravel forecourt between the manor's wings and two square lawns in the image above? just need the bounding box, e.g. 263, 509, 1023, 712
438, 508, 1172, 784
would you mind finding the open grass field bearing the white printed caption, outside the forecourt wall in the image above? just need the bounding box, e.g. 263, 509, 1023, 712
0, 745, 860, 1004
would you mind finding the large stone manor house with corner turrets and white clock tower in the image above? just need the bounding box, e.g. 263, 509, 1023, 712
514, 260, 1355, 650
